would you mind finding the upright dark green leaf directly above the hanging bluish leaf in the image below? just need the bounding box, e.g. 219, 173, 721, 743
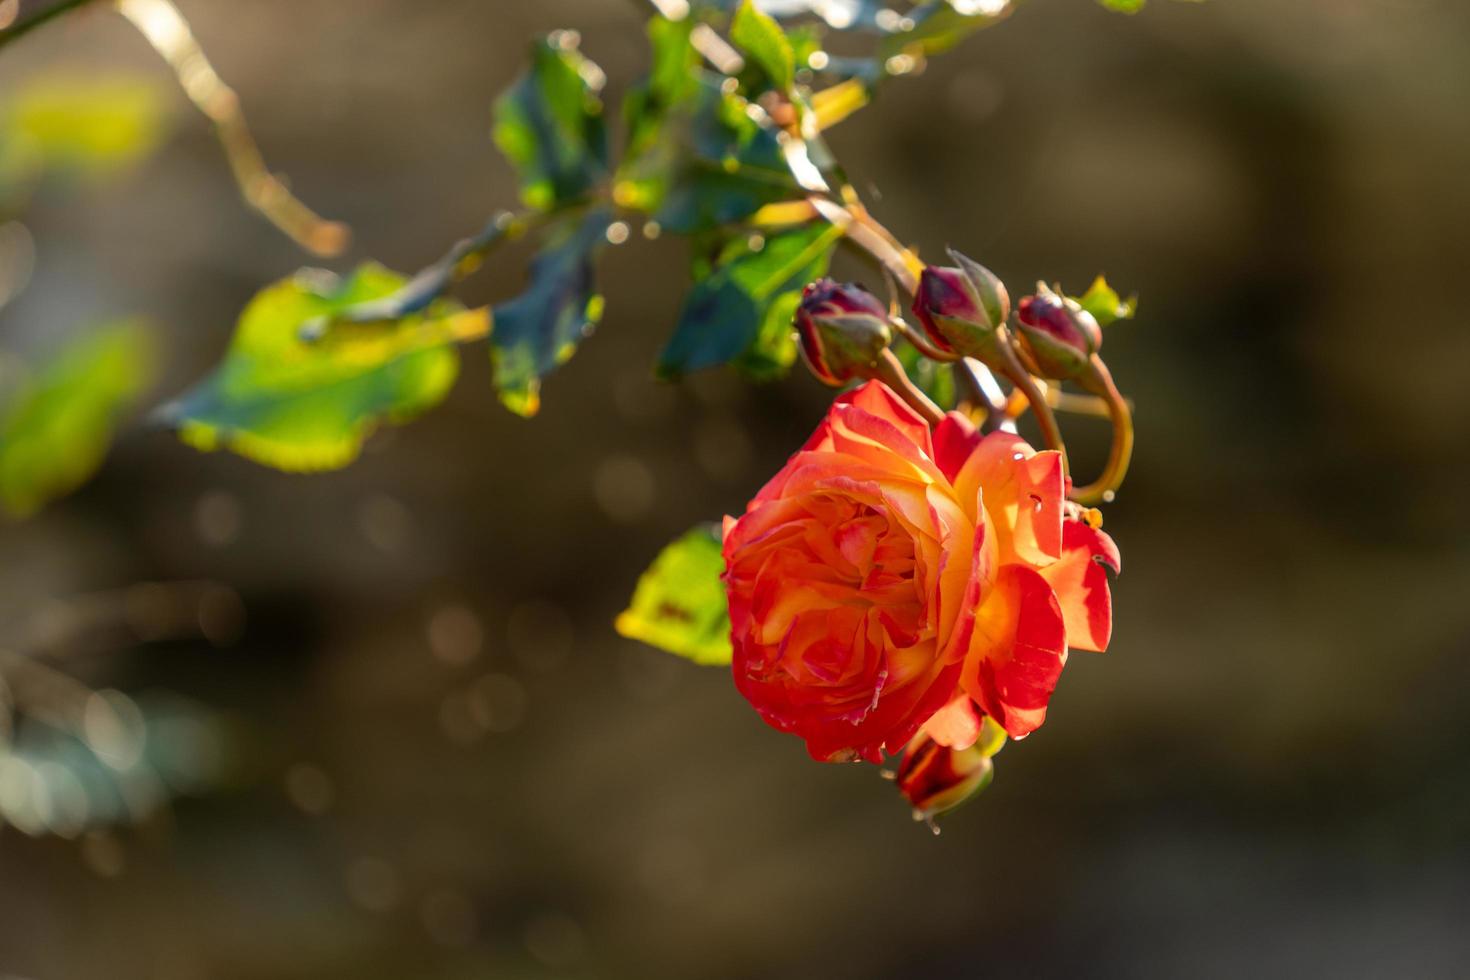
494, 31, 609, 210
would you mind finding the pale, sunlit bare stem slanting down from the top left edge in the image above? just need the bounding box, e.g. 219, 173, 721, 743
115, 0, 351, 257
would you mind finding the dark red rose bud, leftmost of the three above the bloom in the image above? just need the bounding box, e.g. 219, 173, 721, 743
795, 279, 894, 386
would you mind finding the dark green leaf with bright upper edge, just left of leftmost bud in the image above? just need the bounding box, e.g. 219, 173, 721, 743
659, 222, 842, 378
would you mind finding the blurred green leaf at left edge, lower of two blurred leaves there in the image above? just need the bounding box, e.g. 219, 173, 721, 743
0, 322, 157, 517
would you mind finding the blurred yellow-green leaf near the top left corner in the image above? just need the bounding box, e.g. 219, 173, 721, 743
0, 75, 168, 203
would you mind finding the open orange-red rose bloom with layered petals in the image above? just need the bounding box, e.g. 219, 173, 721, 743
723, 381, 1119, 763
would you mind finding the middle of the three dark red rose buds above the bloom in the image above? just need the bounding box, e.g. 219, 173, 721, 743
913, 248, 1010, 360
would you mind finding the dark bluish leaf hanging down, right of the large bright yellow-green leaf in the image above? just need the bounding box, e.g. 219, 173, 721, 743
491, 207, 613, 416
